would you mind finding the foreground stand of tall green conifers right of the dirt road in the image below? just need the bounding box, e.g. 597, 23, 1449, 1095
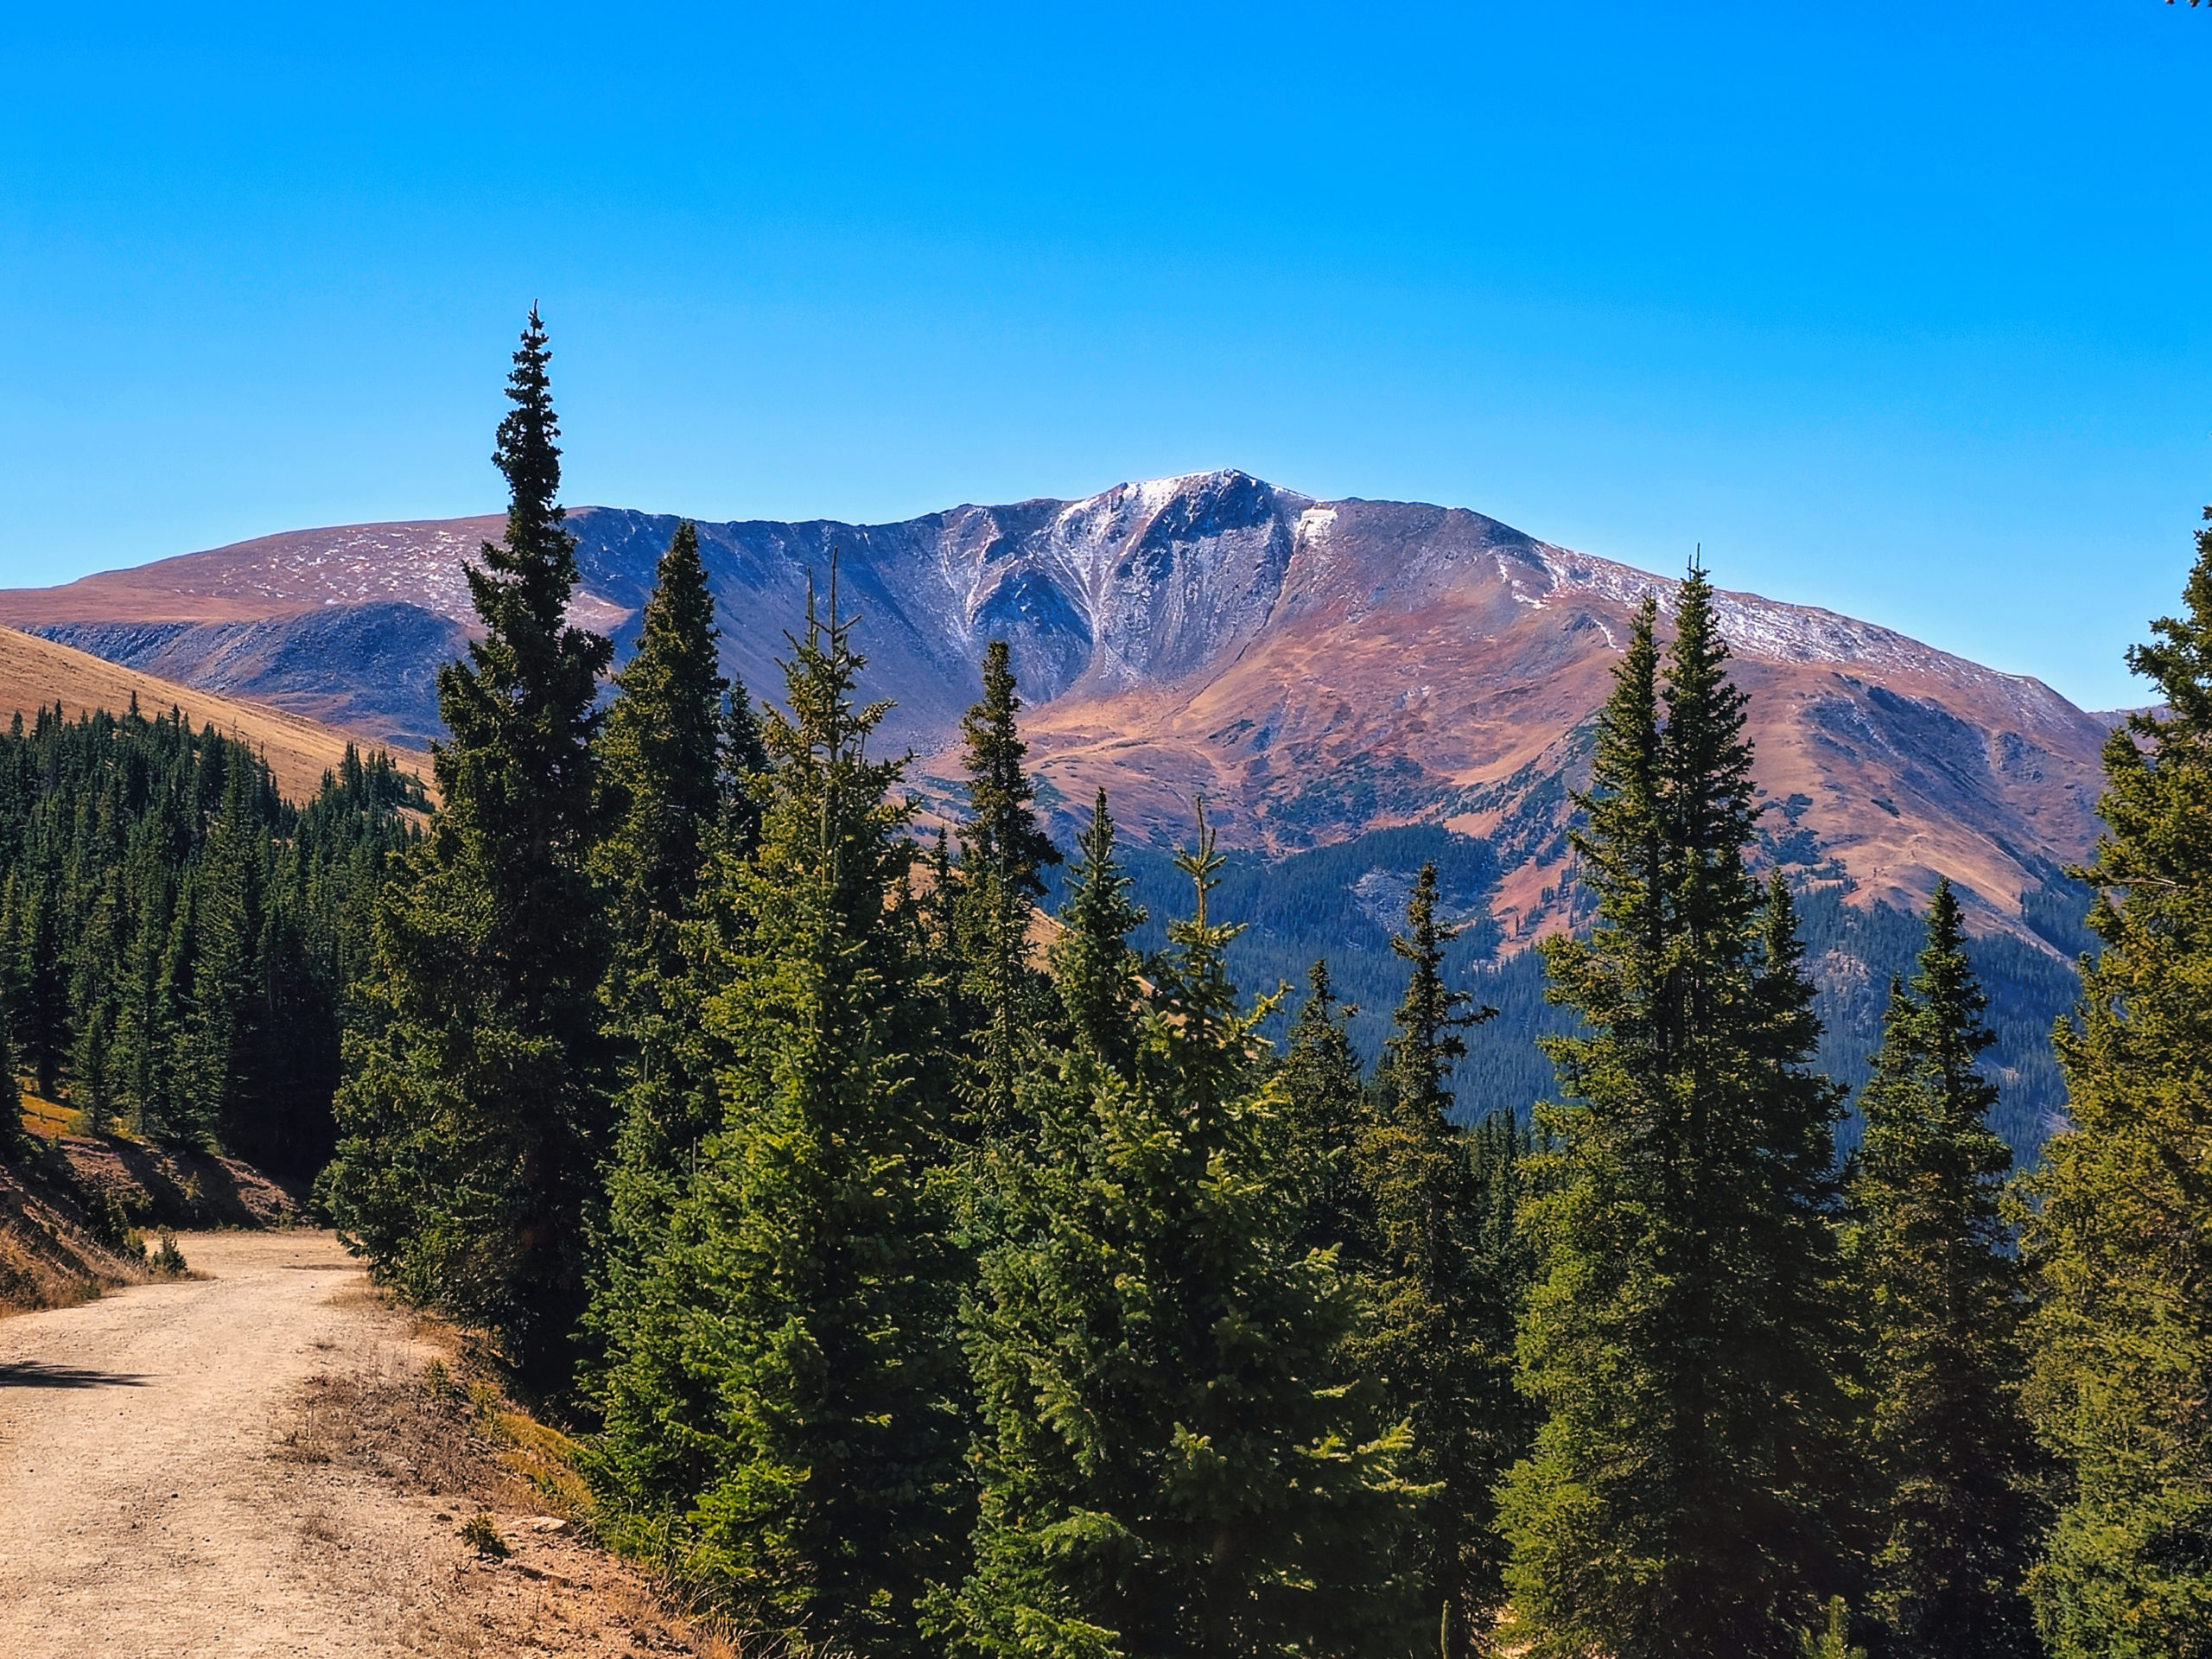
323, 315, 2212, 1659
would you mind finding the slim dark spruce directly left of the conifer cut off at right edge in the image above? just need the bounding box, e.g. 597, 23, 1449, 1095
1849, 880, 2037, 1659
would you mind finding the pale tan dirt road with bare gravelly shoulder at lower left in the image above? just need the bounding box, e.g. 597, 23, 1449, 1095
0, 1232, 710, 1659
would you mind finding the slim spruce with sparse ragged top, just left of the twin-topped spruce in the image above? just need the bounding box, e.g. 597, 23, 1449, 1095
1354, 865, 1526, 1659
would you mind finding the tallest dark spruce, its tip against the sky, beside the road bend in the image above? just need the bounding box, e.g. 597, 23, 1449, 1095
323, 308, 613, 1385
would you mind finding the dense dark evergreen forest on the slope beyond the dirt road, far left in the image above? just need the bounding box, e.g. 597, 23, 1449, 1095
0, 702, 425, 1174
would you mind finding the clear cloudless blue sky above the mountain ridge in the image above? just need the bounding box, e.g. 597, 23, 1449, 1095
0, 0, 2212, 706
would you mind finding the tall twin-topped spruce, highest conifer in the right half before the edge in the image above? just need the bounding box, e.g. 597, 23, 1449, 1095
1502, 569, 1840, 1659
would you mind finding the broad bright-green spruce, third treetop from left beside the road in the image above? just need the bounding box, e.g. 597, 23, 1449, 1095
591, 575, 969, 1655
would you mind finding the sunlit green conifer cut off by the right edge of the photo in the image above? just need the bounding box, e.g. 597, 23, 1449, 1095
2024, 509, 2212, 1659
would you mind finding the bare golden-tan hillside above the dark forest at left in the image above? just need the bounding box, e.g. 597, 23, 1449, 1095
0, 628, 429, 801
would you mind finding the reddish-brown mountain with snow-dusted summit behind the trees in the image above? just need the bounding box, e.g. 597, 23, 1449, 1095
0, 471, 2110, 1146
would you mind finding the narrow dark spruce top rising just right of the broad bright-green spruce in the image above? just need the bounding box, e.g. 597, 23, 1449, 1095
953, 639, 1059, 1137
